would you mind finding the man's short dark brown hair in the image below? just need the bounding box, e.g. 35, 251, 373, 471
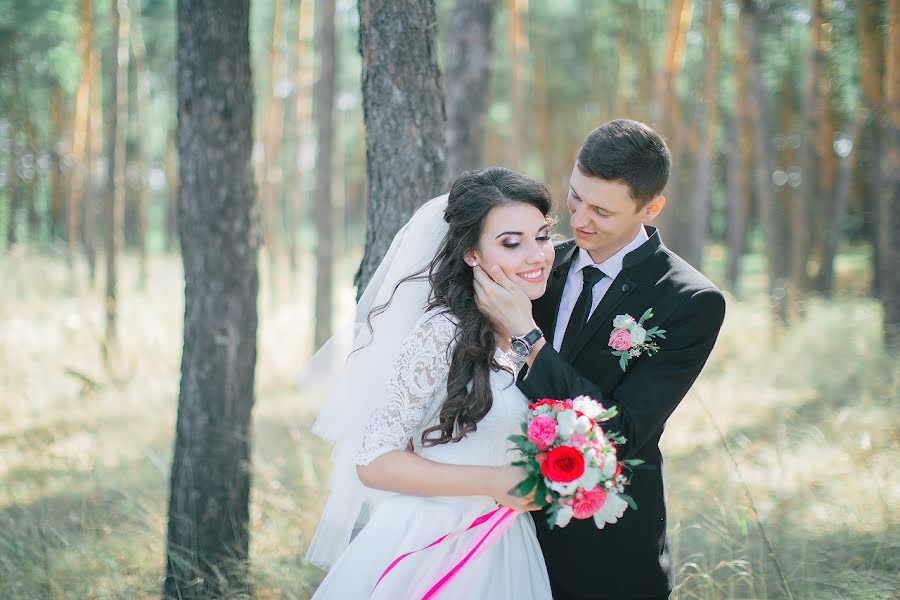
577, 119, 672, 210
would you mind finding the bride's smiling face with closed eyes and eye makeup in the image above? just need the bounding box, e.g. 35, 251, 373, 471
466, 202, 555, 300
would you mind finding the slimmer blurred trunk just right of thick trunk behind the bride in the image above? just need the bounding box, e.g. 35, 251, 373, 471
444, 0, 497, 181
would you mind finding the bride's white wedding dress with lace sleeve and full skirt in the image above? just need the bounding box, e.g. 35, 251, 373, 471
313, 312, 551, 600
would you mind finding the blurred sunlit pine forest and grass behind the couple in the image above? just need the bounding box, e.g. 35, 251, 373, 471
0, 0, 900, 599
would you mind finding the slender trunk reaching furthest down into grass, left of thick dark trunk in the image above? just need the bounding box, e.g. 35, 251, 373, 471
104, 0, 129, 346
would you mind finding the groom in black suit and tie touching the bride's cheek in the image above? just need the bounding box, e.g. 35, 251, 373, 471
475, 120, 725, 600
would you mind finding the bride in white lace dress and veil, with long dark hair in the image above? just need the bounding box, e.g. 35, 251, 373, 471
306, 167, 554, 600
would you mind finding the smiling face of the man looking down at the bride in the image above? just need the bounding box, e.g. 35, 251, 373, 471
566, 165, 665, 263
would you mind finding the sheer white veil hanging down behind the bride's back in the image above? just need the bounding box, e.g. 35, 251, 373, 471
299, 194, 447, 569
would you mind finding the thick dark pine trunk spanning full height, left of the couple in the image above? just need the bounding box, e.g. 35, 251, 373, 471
163, 0, 259, 599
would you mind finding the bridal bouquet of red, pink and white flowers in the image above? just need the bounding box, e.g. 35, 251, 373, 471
509, 396, 642, 529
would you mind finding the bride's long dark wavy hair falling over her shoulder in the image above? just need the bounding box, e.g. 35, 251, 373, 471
422, 167, 552, 446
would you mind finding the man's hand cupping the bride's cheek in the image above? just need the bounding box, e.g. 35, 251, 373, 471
474, 265, 534, 336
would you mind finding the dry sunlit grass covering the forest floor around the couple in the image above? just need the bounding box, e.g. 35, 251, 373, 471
0, 246, 900, 600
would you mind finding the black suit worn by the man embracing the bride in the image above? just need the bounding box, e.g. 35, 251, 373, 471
518, 227, 725, 600
